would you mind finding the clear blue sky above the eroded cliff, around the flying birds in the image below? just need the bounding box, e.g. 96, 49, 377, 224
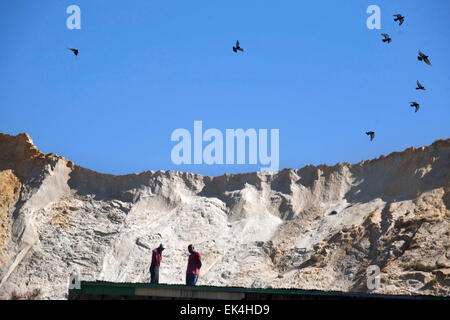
0, 0, 450, 175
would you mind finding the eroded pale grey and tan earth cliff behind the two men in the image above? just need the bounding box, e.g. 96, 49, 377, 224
0, 134, 450, 299
